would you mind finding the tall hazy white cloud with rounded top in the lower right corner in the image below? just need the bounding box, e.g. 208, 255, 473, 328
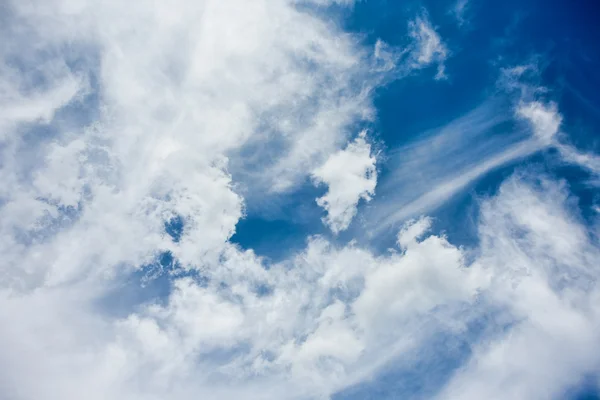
440, 179, 600, 399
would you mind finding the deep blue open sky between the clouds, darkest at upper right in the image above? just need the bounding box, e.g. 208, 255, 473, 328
233, 0, 600, 260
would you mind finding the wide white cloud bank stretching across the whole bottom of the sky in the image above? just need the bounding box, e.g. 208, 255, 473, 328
0, 170, 600, 399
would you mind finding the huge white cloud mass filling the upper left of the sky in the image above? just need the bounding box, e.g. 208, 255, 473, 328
0, 0, 396, 284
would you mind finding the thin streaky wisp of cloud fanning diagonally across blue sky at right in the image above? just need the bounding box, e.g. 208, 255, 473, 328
367, 69, 600, 235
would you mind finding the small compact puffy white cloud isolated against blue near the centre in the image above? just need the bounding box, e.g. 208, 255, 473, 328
312, 132, 377, 233
